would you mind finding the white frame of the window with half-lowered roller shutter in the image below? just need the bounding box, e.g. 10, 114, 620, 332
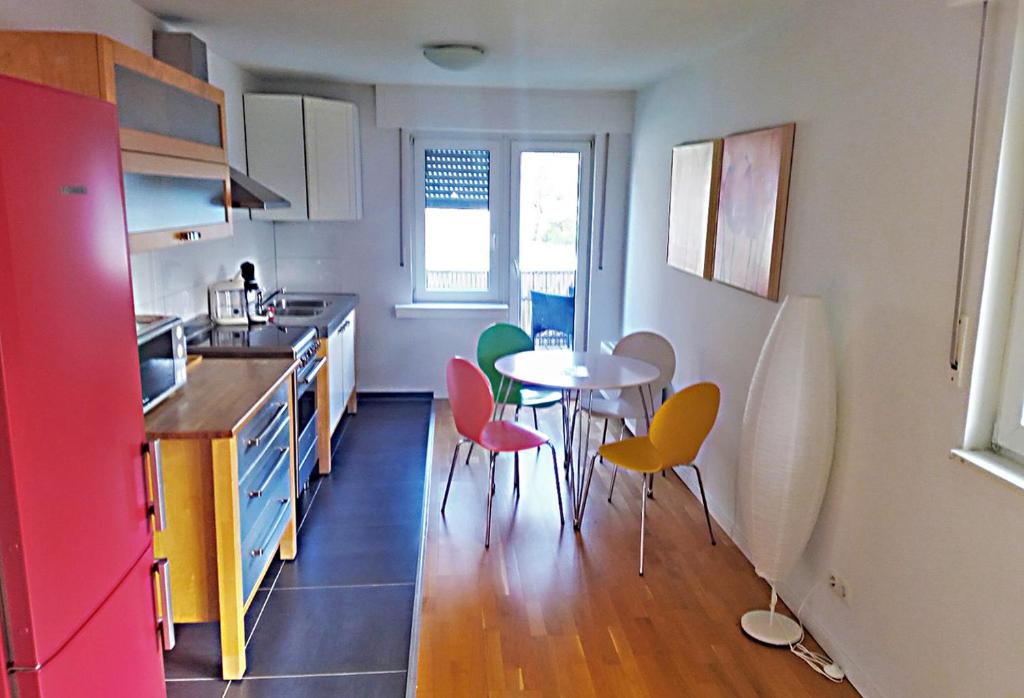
412, 133, 509, 303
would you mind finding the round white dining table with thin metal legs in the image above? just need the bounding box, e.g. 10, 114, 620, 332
495, 349, 658, 529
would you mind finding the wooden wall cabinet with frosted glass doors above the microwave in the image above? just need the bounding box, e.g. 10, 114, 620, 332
0, 32, 231, 252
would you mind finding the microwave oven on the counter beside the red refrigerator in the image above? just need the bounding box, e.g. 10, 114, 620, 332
135, 315, 187, 413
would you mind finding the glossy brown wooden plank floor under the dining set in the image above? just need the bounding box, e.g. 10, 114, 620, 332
417, 401, 857, 698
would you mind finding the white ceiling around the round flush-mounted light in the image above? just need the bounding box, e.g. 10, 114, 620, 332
136, 0, 806, 89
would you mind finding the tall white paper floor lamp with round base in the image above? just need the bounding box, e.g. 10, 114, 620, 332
736, 296, 836, 645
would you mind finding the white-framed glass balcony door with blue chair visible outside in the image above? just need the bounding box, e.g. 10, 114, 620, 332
509, 140, 591, 350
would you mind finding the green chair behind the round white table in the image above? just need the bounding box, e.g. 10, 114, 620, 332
466, 322, 562, 463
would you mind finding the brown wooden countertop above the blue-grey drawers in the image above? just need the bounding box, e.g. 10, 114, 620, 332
145, 358, 298, 439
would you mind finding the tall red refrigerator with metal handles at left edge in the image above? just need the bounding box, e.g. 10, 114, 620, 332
0, 77, 170, 698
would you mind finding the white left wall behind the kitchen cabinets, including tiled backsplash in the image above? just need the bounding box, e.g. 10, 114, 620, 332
0, 0, 276, 317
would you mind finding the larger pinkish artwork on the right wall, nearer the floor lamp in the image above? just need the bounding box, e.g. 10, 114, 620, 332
714, 124, 797, 301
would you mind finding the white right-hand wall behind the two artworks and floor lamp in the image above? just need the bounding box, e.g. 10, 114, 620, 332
624, 0, 1024, 698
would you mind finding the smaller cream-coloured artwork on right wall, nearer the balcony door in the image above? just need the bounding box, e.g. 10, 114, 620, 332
669, 138, 722, 278
